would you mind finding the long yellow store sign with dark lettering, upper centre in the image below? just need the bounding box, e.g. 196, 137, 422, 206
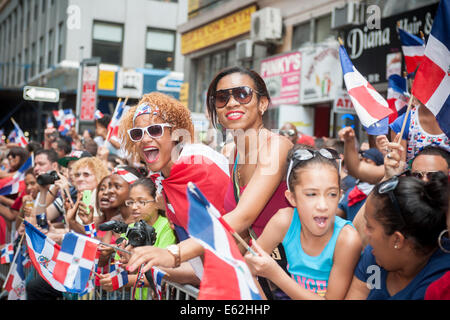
181, 5, 256, 54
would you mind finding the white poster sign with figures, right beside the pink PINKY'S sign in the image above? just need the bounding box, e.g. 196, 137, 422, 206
300, 42, 342, 104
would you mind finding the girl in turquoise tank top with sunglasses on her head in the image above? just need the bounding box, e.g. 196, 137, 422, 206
245, 146, 361, 300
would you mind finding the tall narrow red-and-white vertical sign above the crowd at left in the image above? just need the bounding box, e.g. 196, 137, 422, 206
79, 60, 99, 121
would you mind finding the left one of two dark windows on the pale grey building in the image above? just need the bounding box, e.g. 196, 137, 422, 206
92, 21, 123, 65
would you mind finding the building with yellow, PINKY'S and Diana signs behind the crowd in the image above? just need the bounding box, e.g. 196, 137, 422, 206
178, 0, 439, 144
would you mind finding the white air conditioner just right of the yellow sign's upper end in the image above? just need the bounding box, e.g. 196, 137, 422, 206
250, 7, 283, 43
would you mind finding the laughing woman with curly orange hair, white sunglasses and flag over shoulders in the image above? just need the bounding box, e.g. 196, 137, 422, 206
119, 92, 230, 277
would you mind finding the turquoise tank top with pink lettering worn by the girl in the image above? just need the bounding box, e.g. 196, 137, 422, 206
282, 208, 353, 296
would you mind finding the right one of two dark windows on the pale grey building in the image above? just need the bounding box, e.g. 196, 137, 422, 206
145, 29, 175, 70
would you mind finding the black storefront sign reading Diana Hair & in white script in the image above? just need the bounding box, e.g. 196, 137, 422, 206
341, 3, 438, 84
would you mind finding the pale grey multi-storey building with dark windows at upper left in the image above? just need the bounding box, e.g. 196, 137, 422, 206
0, 0, 187, 139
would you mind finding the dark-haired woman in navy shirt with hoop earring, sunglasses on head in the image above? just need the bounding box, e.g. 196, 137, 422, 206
347, 174, 450, 300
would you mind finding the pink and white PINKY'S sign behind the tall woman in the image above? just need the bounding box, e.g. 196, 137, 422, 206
260, 51, 302, 106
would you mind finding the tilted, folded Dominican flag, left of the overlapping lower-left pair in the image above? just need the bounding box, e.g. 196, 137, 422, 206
23, 220, 67, 292
